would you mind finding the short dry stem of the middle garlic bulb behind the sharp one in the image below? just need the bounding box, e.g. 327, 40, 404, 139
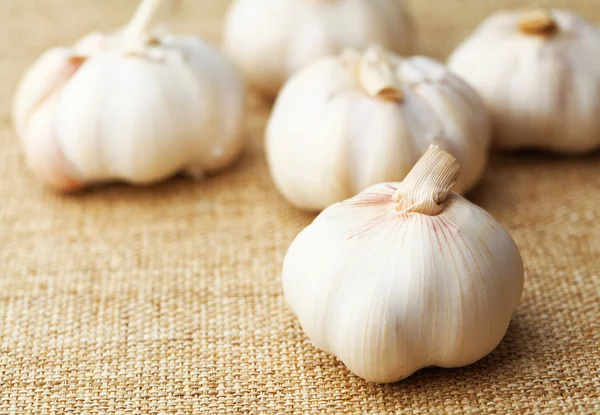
359, 48, 404, 102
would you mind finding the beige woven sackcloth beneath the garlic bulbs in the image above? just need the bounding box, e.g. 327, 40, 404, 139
0, 0, 600, 414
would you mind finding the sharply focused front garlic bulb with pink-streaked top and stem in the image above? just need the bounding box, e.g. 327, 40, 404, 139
282, 147, 523, 382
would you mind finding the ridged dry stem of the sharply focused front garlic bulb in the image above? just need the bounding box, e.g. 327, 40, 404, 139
392, 145, 459, 215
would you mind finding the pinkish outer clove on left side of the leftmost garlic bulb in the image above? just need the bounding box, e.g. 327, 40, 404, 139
13, 48, 85, 191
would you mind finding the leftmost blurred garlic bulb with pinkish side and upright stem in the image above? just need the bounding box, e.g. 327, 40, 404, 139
13, 0, 245, 190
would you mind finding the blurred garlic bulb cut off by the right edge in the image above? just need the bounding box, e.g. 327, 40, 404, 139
448, 9, 600, 153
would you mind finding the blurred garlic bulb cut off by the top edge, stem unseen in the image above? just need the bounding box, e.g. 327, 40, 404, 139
225, 0, 414, 96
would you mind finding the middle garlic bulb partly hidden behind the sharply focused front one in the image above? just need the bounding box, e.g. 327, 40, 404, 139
266, 46, 490, 210
